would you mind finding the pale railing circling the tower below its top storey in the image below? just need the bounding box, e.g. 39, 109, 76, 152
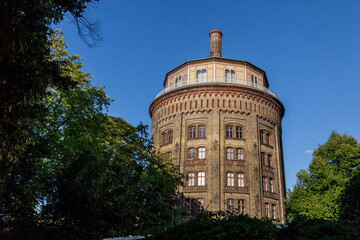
155, 78, 277, 99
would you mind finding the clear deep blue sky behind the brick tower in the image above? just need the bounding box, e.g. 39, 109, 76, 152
58, 0, 360, 188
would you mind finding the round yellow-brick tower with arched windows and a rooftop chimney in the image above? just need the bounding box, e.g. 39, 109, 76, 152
149, 30, 285, 223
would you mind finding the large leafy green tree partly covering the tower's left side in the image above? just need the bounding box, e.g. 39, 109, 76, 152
0, 31, 177, 239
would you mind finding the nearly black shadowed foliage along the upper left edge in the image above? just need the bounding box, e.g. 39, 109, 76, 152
0, 0, 97, 199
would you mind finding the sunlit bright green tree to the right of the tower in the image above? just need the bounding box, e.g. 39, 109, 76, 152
287, 132, 360, 220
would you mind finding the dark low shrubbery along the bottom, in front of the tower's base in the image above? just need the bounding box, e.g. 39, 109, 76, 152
148, 212, 360, 240
